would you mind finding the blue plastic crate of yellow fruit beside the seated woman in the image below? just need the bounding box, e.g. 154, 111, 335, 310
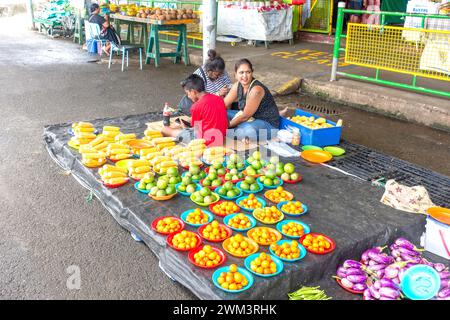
280, 109, 342, 147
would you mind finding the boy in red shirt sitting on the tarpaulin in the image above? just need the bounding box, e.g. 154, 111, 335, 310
162, 74, 228, 146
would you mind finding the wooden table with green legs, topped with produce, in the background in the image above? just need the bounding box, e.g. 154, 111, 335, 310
111, 14, 199, 67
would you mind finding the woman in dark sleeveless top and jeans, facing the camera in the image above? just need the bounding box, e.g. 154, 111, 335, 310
224, 59, 280, 141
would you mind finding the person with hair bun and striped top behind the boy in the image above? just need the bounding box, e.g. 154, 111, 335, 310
178, 49, 231, 115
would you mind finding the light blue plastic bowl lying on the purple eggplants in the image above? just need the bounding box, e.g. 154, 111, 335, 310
400, 264, 441, 300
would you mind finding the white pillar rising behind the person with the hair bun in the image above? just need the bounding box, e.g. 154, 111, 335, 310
203, 0, 217, 63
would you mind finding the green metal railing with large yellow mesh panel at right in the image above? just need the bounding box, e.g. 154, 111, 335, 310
331, 3, 450, 97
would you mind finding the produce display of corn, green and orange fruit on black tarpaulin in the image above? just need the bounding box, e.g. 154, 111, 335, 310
44, 113, 450, 299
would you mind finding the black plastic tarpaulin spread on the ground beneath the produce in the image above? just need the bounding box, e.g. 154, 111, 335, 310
43, 113, 425, 299
